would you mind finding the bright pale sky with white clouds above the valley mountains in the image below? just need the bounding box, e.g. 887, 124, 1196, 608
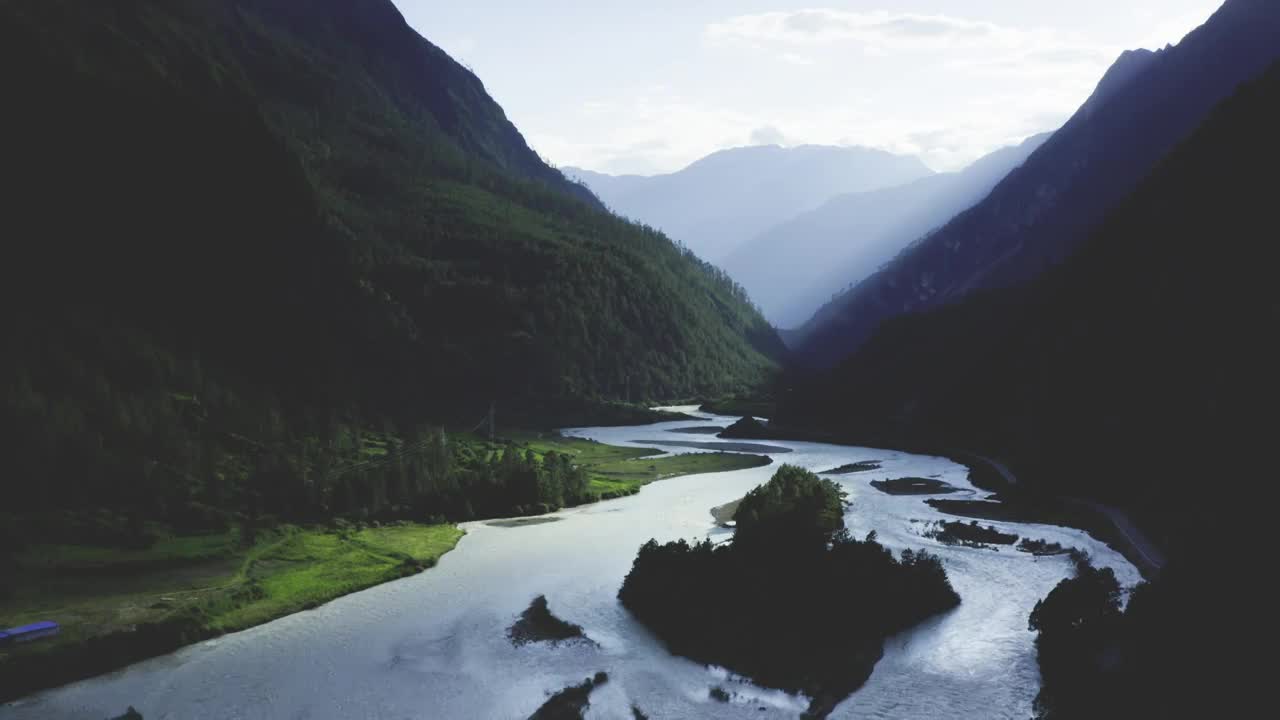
396, 0, 1222, 174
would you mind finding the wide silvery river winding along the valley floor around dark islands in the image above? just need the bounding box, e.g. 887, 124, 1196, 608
0, 409, 1139, 720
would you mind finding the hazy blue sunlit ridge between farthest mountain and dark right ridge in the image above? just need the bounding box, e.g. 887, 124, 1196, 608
727, 133, 1050, 328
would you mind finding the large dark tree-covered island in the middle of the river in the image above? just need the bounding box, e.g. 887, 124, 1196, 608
618, 465, 960, 716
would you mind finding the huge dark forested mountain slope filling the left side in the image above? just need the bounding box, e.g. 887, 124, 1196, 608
0, 0, 782, 519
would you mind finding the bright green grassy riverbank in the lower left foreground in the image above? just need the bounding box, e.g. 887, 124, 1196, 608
0, 523, 463, 701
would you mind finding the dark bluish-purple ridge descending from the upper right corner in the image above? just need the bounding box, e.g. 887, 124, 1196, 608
799, 0, 1280, 365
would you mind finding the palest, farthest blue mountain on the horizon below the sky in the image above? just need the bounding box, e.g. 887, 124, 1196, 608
564, 145, 933, 263
